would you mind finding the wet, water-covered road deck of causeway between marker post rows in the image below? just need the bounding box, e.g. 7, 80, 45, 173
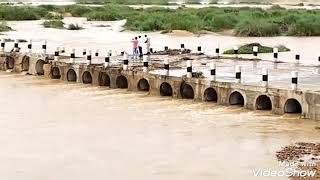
52, 51, 320, 91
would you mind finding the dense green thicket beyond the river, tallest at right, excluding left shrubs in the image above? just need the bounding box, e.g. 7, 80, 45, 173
86, 5, 320, 37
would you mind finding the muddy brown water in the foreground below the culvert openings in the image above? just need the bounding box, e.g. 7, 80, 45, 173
0, 72, 318, 180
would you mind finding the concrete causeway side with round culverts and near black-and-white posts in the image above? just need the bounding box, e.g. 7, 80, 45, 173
0, 40, 320, 120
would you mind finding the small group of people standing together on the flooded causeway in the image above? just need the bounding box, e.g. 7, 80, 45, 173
131, 35, 150, 59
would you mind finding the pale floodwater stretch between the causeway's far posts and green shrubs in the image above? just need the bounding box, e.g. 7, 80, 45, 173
0, 18, 320, 65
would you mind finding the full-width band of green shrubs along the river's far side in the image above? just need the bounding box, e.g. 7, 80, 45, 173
0, 4, 320, 36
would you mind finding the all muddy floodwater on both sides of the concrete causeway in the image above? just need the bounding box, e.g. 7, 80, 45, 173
0, 5, 320, 180
